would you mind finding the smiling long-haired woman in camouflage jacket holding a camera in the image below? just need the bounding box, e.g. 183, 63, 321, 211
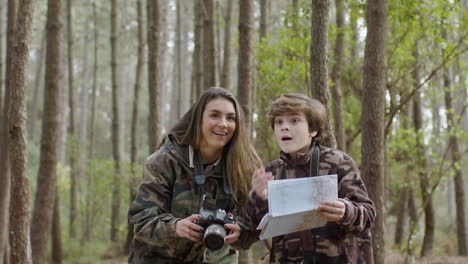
129, 88, 262, 264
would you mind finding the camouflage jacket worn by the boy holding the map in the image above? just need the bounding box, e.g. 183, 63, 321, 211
246, 146, 376, 264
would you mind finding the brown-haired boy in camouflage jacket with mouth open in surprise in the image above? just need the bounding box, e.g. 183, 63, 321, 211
246, 93, 375, 264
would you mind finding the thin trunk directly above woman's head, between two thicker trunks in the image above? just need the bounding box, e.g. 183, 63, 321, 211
221, 0, 234, 90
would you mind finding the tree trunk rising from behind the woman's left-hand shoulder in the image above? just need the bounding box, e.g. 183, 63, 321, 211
147, 0, 160, 153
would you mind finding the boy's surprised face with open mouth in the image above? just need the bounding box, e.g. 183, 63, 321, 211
273, 113, 317, 153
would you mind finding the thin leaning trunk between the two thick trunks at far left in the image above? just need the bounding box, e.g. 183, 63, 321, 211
28, 29, 46, 142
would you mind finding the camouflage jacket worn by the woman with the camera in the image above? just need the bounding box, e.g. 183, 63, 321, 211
128, 135, 255, 264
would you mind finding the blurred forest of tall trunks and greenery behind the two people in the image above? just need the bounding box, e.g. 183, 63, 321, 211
0, 0, 468, 264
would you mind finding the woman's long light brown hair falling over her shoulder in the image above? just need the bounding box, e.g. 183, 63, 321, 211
169, 87, 262, 204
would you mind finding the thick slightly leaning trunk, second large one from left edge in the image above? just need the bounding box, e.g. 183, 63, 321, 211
31, 0, 62, 264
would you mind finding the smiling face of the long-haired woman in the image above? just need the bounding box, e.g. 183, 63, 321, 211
200, 98, 236, 152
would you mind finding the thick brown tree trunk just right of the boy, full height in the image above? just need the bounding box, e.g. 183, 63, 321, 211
361, 0, 388, 263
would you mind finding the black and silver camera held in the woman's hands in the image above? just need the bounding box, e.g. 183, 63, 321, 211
198, 195, 236, 251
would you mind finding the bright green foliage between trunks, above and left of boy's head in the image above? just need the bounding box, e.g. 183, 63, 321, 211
255, 3, 310, 162
